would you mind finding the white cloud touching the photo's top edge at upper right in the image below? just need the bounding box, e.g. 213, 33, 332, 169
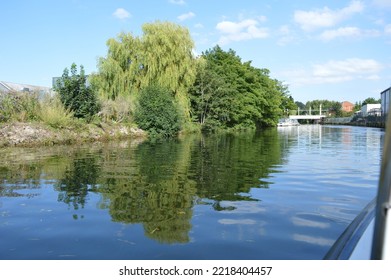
294, 1, 364, 31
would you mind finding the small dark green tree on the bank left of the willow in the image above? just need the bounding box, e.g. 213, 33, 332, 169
55, 63, 100, 120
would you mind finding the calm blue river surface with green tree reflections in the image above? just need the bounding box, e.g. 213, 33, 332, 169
0, 125, 384, 260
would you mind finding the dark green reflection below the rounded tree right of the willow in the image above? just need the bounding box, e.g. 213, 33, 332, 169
191, 129, 281, 208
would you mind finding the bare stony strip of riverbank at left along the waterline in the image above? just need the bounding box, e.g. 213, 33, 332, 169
0, 122, 147, 148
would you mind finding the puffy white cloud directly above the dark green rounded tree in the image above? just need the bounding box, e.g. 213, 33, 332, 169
216, 19, 269, 45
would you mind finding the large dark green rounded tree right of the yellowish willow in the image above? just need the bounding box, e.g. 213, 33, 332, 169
190, 46, 294, 129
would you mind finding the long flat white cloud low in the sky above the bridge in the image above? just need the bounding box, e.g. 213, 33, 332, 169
282, 58, 383, 86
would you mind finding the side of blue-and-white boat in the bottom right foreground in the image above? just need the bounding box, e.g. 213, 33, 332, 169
324, 114, 391, 260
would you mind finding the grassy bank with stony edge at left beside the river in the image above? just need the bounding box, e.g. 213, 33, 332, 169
0, 93, 146, 147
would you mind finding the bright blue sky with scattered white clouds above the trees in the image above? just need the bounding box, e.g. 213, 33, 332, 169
0, 0, 391, 103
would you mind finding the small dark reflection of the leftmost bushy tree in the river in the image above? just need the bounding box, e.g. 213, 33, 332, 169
56, 157, 100, 210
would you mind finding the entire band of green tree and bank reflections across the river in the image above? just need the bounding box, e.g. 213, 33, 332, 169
0, 130, 281, 243
